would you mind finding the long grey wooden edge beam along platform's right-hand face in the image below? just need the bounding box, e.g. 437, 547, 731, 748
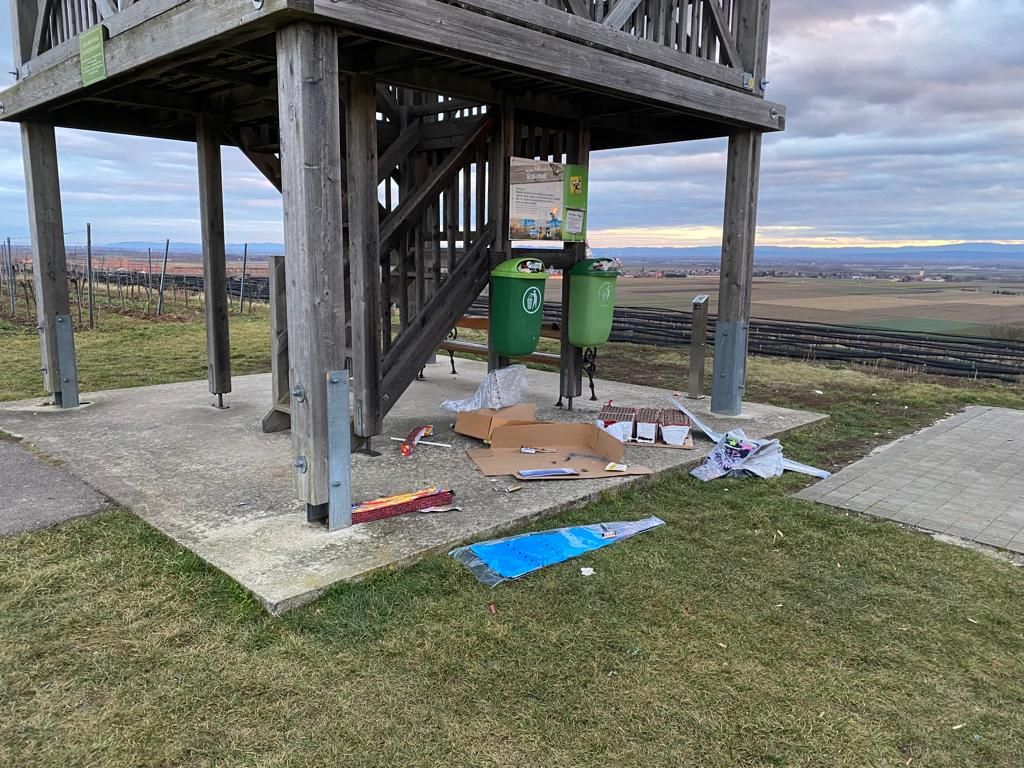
313, 0, 785, 131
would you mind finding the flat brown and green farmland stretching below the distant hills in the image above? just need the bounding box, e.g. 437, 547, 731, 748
548, 275, 1024, 337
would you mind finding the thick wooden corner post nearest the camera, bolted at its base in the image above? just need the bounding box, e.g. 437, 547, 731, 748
278, 23, 345, 519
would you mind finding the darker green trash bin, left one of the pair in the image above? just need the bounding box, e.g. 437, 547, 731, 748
490, 259, 548, 357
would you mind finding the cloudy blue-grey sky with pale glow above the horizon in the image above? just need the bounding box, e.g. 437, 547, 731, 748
0, 0, 1024, 246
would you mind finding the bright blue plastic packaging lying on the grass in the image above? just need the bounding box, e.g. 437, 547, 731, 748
449, 517, 665, 587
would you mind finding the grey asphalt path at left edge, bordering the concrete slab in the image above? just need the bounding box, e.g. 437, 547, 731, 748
0, 439, 108, 536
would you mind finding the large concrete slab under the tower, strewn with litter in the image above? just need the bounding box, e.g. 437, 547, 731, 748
0, 360, 826, 612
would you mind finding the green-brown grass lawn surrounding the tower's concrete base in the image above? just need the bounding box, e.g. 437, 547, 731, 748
0, 309, 1024, 768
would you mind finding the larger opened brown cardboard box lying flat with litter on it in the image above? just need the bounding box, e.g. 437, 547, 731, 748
467, 424, 654, 480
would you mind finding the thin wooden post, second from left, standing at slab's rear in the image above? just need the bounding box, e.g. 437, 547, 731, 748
195, 114, 231, 406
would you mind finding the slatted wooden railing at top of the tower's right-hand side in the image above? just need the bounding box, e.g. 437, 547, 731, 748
537, 0, 742, 70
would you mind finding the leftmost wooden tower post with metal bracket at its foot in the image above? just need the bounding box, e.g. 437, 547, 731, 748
22, 123, 75, 404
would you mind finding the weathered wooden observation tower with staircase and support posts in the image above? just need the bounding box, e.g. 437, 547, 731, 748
0, 0, 784, 518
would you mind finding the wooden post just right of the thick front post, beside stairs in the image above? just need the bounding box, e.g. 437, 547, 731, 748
345, 75, 382, 437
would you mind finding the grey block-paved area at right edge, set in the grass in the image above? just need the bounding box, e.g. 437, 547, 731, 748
796, 407, 1024, 554
